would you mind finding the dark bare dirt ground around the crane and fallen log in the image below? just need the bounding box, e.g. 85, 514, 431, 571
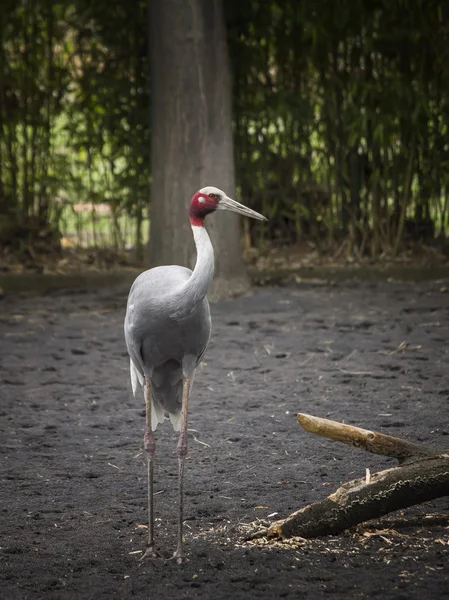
0, 280, 449, 600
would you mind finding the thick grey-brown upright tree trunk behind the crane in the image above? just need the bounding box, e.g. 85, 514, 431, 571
149, 0, 249, 299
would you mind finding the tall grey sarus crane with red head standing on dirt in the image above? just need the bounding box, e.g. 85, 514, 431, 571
124, 186, 266, 564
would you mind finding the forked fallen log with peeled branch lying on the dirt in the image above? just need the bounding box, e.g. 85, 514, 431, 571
260, 414, 449, 538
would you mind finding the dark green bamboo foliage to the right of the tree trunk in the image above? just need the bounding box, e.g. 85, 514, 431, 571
225, 0, 449, 256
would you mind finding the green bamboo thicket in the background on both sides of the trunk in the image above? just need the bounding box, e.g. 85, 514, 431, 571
0, 0, 449, 258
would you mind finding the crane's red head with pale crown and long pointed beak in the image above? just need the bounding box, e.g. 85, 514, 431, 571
189, 185, 267, 227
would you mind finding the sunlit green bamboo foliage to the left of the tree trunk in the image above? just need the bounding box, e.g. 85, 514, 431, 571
0, 0, 150, 254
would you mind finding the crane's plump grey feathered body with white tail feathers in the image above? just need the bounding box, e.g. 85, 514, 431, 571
124, 265, 211, 430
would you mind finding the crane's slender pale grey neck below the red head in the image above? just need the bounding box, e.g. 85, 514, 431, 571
172, 225, 214, 314
